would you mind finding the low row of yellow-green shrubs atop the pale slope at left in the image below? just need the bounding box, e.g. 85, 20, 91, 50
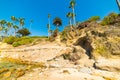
3, 36, 48, 47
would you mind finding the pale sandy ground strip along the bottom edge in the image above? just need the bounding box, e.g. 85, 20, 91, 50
17, 68, 120, 80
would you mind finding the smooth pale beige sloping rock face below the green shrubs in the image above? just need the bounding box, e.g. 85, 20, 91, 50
0, 44, 73, 62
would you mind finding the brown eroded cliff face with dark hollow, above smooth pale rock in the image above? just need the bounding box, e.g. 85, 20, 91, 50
74, 26, 120, 59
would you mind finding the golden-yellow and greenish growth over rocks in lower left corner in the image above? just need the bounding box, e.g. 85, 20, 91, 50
0, 58, 46, 80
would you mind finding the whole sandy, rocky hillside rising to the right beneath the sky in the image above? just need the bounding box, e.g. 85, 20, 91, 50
0, 13, 120, 80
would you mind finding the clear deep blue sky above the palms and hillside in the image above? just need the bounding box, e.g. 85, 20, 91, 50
0, 0, 119, 36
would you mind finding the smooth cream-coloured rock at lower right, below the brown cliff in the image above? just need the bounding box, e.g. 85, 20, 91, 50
95, 58, 120, 72
